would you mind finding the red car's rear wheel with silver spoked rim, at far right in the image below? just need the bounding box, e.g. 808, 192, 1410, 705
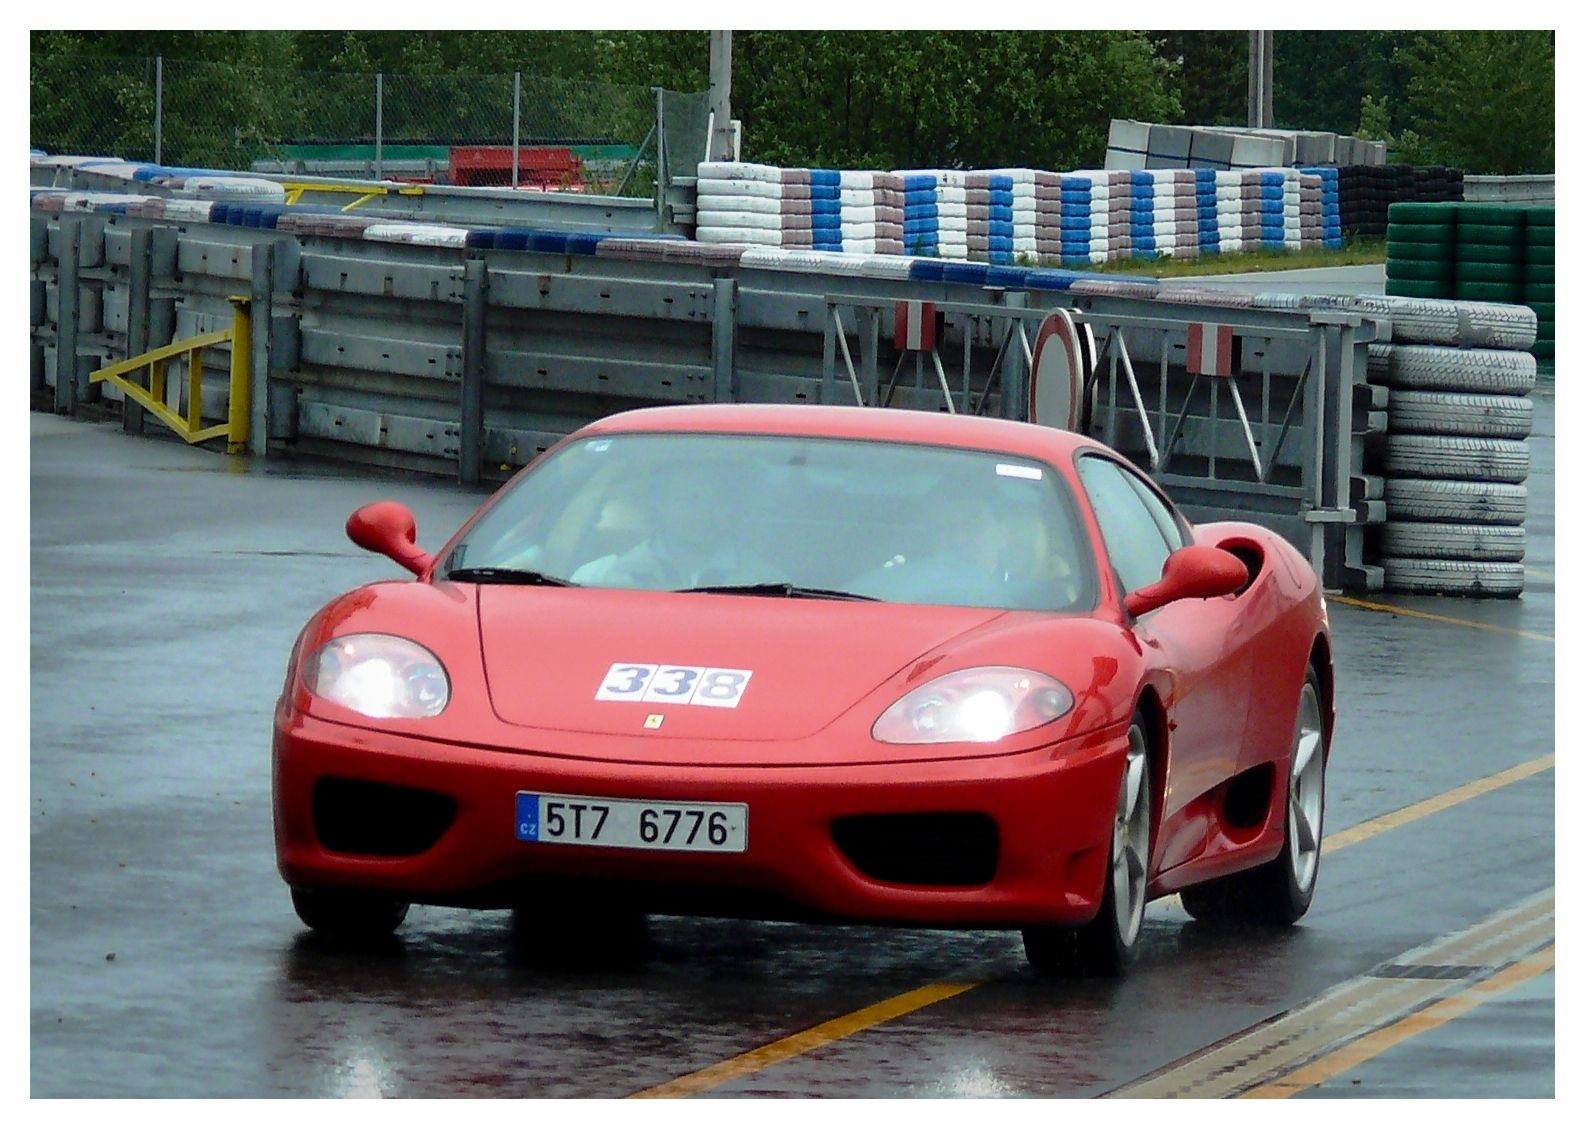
1179, 668, 1330, 926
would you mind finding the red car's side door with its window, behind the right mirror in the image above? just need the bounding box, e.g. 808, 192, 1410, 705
1076, 452, 1251, 871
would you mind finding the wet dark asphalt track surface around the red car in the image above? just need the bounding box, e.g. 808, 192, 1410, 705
29, 294, 1555, 1097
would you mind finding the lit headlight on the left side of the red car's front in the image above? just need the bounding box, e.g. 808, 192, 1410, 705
303, 634, 452, 717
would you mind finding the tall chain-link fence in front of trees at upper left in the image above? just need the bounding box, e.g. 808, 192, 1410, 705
30, 57, 708, 197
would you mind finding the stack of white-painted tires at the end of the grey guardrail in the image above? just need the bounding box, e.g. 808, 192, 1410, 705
1355, 298, 1536, 596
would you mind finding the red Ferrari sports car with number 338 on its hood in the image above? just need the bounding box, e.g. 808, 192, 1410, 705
274, 404, 1333, 974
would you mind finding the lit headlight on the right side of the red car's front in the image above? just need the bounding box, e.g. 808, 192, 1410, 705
870, 666, 1073, 745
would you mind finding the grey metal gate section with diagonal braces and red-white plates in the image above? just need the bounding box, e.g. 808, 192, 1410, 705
821, 292, 1385, 588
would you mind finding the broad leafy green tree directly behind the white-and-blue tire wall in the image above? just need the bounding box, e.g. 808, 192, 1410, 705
732, 32, 1178, 170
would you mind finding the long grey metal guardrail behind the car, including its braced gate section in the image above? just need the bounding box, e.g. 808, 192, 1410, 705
30, 204, 1381, 588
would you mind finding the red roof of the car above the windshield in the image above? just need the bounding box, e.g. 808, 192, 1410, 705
583, 404, 1102, 461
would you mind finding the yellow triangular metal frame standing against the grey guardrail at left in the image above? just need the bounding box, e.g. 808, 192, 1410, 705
89, 295, 254, 455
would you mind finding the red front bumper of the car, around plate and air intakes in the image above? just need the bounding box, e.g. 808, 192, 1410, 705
274, 715, 1127, 928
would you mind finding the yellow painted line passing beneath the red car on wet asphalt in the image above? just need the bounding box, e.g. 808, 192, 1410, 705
629, 754, 1558, 1097
